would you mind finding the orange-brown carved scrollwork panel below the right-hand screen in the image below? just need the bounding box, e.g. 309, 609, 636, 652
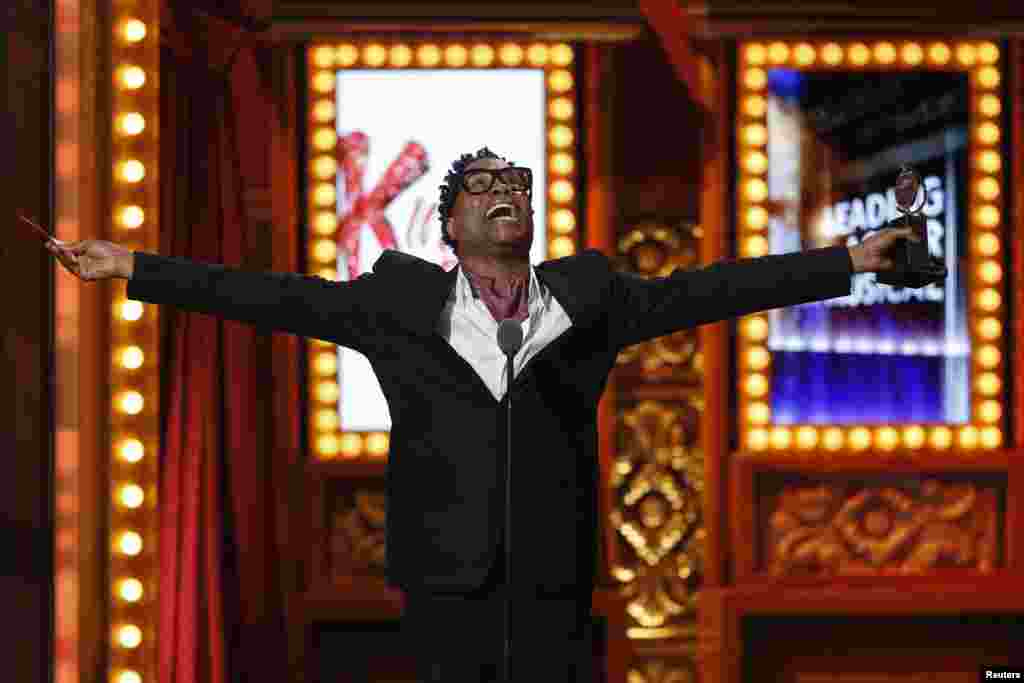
762, 478, 1000, 575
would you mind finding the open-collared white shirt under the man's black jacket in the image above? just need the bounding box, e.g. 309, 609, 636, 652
437, 266, 572, 400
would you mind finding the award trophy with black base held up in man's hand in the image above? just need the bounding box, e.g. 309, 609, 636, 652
876, 164, 946, 289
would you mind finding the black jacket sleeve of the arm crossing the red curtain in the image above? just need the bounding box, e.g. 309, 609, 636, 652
127, 252, 378, 350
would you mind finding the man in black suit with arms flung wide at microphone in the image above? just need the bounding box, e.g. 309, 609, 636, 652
48, 148, 929, 683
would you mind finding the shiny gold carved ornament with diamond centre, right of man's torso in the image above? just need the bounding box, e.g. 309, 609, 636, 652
609, 398, 705, 637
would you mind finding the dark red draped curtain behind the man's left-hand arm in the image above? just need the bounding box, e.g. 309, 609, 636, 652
158, 3, 295, 683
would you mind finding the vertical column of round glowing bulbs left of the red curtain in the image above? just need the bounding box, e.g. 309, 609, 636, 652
110, 12, 159, 683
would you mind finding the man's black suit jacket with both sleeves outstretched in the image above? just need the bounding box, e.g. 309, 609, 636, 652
127, 247, 852, 596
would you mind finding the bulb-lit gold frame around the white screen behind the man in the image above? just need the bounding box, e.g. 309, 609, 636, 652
305, 36, 580, 462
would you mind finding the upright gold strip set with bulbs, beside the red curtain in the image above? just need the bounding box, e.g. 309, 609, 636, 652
102, 0, 161, 683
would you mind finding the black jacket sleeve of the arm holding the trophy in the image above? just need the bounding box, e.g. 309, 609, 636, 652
609, 247, 853, 348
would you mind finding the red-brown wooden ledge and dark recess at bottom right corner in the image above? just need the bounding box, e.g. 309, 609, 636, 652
705, 571, 1024, 683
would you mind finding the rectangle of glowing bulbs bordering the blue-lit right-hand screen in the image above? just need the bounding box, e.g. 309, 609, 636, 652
737, 41, 1004, 450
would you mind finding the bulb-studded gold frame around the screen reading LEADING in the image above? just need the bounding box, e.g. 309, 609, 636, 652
734, 37, 1010, 453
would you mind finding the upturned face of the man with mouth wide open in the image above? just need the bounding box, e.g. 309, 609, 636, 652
449, 159, 534, 258
